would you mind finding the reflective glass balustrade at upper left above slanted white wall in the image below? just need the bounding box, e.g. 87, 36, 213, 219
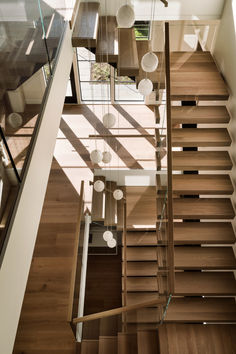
0, 0, 64, 254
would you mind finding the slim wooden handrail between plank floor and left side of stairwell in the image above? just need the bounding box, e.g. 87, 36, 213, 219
67, 181, 84, 322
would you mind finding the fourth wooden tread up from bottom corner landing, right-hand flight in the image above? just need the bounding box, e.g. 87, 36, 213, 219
171, 222, 235, 244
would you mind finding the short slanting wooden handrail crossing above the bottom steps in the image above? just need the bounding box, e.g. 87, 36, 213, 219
73, 298, 166, 324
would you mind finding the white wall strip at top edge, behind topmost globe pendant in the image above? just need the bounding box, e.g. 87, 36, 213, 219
90, 0, 224, 20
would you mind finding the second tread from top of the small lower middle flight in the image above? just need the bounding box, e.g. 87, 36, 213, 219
126, 247, 157, 261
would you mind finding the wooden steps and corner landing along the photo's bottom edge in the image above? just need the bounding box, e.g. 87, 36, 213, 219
80, 324, 236, 354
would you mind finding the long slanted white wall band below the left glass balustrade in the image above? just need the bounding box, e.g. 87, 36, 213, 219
0, 22, 73, 354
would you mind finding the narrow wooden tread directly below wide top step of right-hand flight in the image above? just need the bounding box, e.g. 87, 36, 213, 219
171, 106, 230, 124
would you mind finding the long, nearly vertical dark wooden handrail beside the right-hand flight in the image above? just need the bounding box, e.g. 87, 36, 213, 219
165, 22, 175, 294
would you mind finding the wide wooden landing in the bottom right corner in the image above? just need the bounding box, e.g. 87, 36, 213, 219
158, 323, 236, 354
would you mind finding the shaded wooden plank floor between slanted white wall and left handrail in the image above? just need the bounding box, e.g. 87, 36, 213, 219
14, 161, 79, 354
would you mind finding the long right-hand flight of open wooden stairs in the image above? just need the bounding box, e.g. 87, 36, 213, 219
156, 62, 236, 322
